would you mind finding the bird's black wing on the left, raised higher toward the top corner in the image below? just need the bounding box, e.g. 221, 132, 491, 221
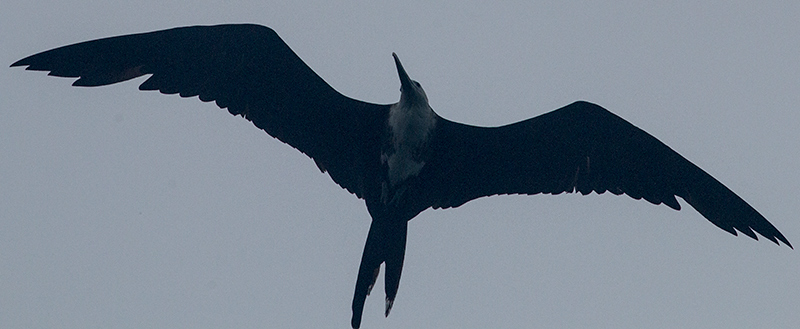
11, 24, 388, 197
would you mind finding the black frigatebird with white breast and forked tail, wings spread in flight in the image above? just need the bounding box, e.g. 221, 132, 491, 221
11, 24, 792, 328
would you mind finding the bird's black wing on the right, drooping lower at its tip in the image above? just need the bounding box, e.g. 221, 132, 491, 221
418, 102, 791, 247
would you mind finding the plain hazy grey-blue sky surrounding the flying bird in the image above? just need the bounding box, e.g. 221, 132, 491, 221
0, 1, 800, 328
